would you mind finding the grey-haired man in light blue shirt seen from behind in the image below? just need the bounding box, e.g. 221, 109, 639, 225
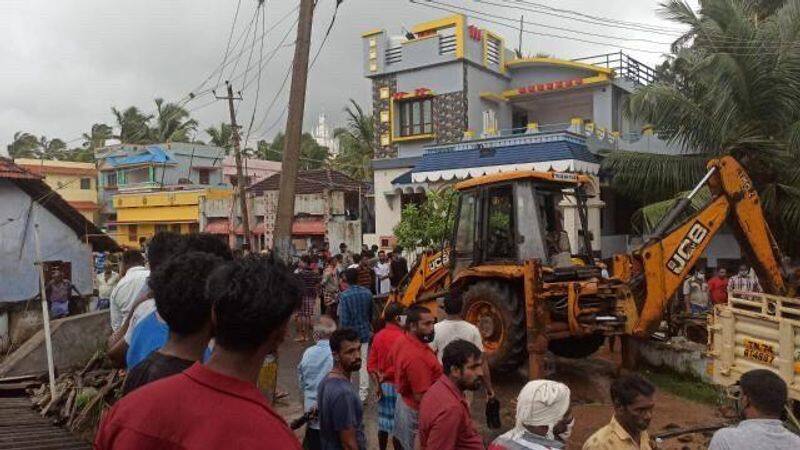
297, 316, 336, 450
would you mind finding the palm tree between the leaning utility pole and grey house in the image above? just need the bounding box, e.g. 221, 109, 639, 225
333, 99, 375, 181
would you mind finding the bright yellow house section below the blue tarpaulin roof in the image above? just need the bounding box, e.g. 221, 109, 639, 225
110, 188, 233, 248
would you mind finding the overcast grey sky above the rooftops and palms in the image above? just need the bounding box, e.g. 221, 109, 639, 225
0, 0, 696, 154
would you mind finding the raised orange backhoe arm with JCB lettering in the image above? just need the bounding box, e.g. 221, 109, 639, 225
632, 156, 786, 336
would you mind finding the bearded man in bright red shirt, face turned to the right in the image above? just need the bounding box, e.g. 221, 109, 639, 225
392, 306, 442, 449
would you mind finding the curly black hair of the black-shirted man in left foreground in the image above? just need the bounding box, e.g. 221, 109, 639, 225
147, 252, 223, 334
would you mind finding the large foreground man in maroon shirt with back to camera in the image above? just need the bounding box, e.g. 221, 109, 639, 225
94, 257, 303, 450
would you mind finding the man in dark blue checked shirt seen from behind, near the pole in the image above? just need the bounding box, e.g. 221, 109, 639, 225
338, 269, 372, 402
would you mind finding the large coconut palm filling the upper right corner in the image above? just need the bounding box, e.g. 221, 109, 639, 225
603, 0, 800, 247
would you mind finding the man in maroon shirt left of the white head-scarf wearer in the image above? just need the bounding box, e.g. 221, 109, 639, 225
419, 339, 484, 450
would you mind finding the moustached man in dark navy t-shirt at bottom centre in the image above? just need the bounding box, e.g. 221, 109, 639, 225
317, 328, 367, 450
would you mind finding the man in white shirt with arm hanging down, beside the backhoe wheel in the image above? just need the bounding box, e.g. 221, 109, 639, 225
430, 295, 494, 398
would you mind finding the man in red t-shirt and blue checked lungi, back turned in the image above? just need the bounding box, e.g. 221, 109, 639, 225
367, 302, 405, 450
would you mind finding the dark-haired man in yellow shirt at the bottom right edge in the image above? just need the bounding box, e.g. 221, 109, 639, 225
583, 374, 656, 450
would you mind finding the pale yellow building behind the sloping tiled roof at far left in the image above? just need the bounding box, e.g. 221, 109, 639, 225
14, 158, 98, 223
